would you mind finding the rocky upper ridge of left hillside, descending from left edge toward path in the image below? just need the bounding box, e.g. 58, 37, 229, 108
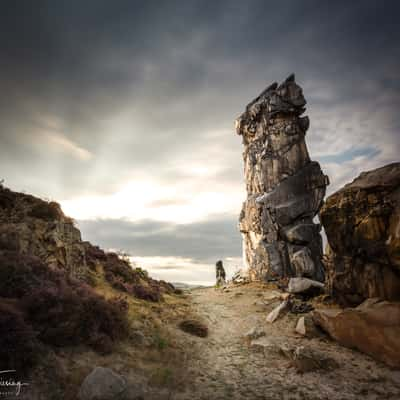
0, 185, 174, 301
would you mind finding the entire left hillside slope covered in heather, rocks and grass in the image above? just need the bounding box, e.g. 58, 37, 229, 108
0, 186, 189, 399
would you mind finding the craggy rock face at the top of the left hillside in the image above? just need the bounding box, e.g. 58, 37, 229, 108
0, 187, 89, 278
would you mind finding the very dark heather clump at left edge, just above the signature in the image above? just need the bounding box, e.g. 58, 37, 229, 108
0, 301, 39, 373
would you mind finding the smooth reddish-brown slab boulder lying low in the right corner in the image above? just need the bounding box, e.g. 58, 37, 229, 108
312, 299, 400, 368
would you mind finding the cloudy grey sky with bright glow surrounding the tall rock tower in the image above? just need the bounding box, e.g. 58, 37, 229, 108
0, 0, 400, 284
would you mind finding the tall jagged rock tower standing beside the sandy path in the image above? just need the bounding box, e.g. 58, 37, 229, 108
236, 75, 329, 281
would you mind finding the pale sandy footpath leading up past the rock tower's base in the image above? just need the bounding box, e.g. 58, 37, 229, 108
170, 284, 400, 400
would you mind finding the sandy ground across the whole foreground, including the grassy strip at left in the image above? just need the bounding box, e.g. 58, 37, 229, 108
22, 283, 400, 400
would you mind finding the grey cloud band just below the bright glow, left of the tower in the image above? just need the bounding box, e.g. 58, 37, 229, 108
79, 216, 241, 263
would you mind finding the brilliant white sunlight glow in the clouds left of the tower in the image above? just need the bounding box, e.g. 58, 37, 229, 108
61, 176, 244, 224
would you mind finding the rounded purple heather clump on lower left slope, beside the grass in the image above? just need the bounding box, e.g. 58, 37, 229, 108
24, 284, 128, 350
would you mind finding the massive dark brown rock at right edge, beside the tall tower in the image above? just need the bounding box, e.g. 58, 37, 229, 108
320, 163, 400, 305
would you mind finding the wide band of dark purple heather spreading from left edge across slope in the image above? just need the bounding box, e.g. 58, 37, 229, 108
0, 251, 128, 352
